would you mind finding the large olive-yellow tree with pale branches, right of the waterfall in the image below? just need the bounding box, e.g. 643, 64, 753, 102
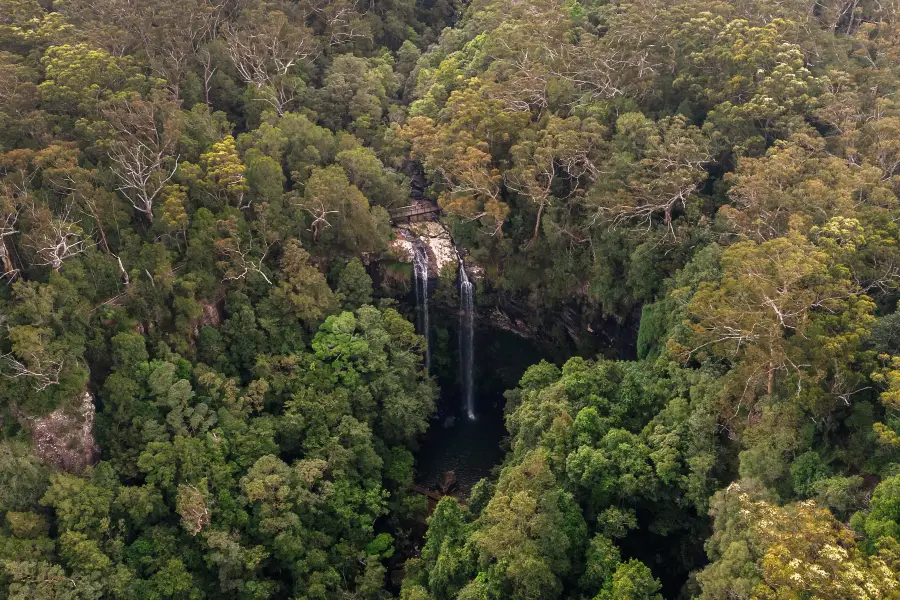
688, 232, 873, 418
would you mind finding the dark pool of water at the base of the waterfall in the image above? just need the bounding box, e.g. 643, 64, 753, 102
416, 400, 506, 499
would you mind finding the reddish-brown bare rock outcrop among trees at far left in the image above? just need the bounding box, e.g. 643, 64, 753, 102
29, 392, 100, 474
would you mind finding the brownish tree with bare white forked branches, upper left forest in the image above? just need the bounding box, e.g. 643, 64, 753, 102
104, 96, 178, 222
